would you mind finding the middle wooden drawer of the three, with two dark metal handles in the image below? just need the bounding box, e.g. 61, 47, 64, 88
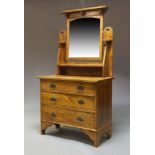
41, 92, 95, 110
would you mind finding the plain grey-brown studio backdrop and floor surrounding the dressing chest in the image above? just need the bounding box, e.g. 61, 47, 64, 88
24, 0, 130, 155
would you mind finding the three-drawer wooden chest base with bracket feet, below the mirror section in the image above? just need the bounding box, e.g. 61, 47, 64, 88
39, 75, 112, 146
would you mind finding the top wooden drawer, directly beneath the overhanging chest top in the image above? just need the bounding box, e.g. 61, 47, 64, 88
41, 80, 95, 96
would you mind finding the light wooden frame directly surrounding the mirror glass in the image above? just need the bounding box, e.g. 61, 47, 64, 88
66, 16, 103, 61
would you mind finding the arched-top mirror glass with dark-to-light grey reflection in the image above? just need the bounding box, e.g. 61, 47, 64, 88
69, 18, 100, 58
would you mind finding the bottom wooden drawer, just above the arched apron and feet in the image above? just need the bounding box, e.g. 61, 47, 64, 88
41, 105, 95, 129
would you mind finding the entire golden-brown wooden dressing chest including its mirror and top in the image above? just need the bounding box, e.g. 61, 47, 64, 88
39, 6, 113, 146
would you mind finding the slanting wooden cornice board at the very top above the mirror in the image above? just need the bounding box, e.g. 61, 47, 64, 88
61, 5, 107, 14
